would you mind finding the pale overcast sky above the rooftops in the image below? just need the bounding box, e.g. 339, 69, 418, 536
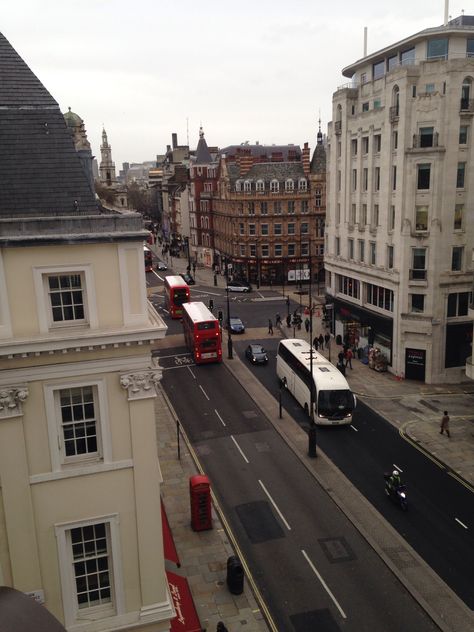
0, 0, 466, 171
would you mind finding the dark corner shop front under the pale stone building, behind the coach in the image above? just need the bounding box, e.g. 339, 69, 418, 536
331, 298, 393, 365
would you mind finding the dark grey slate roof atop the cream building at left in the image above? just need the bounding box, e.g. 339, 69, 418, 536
0, 33, 99, 218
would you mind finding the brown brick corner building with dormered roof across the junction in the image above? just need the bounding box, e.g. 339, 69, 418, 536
213, 138, 325, 286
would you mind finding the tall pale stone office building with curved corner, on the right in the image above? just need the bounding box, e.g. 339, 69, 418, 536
325, 16, 474, 383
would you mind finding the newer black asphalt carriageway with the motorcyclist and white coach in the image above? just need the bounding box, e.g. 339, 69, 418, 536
234, 339, 474, 609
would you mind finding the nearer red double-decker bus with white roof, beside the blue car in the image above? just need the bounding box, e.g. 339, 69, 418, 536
183, 302, 222, 364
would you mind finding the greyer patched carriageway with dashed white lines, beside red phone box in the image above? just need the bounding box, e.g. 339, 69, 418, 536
160, 349, 437, 632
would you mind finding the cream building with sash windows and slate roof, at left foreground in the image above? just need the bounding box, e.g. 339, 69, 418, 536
0, 35, 174, 632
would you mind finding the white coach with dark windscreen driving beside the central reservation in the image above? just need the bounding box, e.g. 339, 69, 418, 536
277, 338, 357, 426
